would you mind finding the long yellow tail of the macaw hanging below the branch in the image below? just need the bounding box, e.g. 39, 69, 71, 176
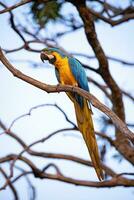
71, 94, 104, 181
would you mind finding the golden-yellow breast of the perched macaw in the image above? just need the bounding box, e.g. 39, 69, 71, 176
53, 52, 77, 86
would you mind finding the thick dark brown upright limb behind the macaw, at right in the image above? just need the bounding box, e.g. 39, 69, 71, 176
70, 0, 134, 166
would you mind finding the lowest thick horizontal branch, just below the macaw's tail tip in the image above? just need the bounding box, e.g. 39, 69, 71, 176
0, 154, 134, 188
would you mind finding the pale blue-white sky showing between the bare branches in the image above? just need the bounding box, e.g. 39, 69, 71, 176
0, 1, 134, 200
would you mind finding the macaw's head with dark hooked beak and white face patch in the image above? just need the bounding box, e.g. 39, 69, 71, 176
40, 48, 66, 64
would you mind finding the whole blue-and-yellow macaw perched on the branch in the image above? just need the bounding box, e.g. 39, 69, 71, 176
40, 48, 103, 180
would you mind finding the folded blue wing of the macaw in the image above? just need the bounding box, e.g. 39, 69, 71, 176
68, 57, 89, 107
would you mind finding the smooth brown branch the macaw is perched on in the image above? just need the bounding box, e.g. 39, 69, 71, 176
0, 50, 134, 144
